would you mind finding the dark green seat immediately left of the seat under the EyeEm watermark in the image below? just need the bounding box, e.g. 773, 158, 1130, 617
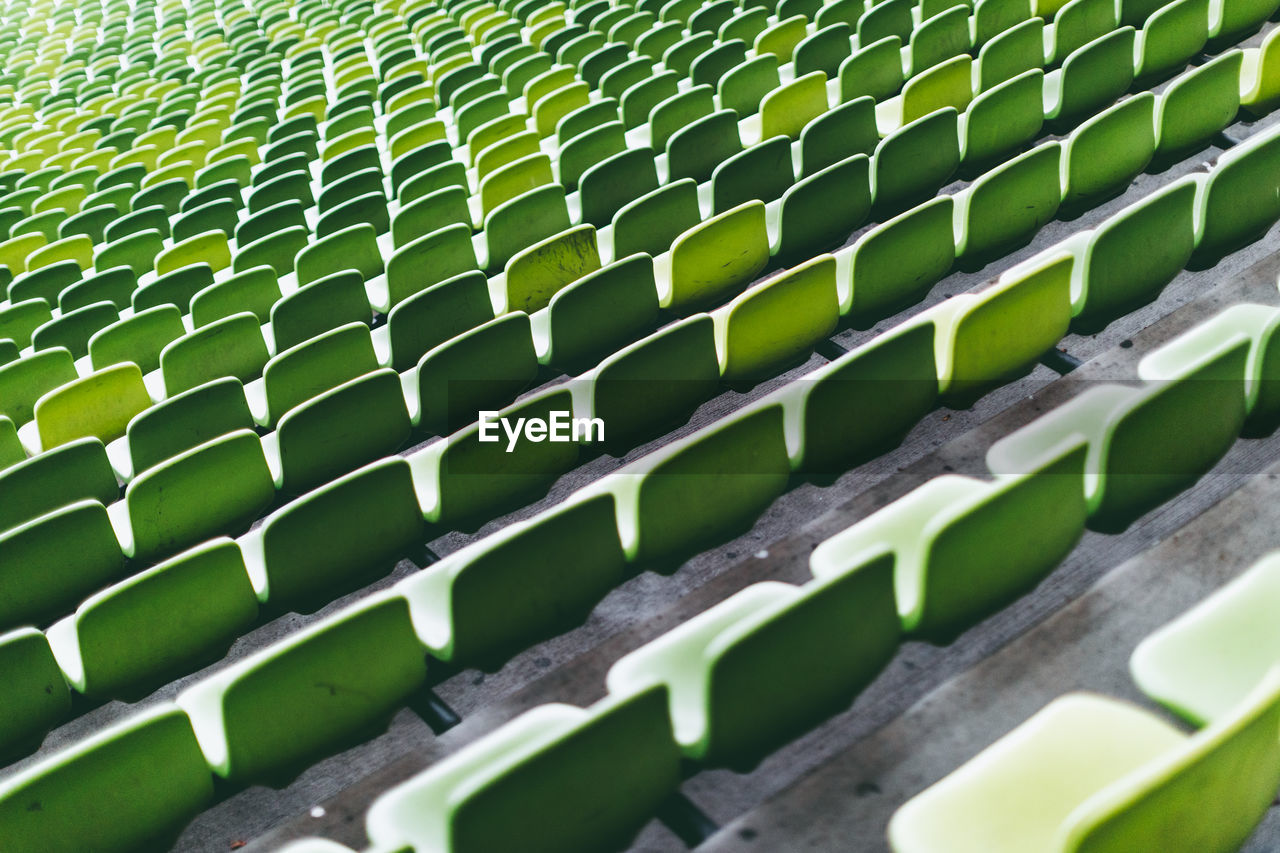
242, 456, 425, 610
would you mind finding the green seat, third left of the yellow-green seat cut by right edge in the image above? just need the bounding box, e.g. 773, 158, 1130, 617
955, 142, 1062, 269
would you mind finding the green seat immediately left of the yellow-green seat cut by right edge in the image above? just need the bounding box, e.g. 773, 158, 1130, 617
1156, 50, 1242, 159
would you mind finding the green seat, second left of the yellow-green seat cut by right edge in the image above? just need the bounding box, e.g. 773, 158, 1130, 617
1062, 92, 1156, 210
